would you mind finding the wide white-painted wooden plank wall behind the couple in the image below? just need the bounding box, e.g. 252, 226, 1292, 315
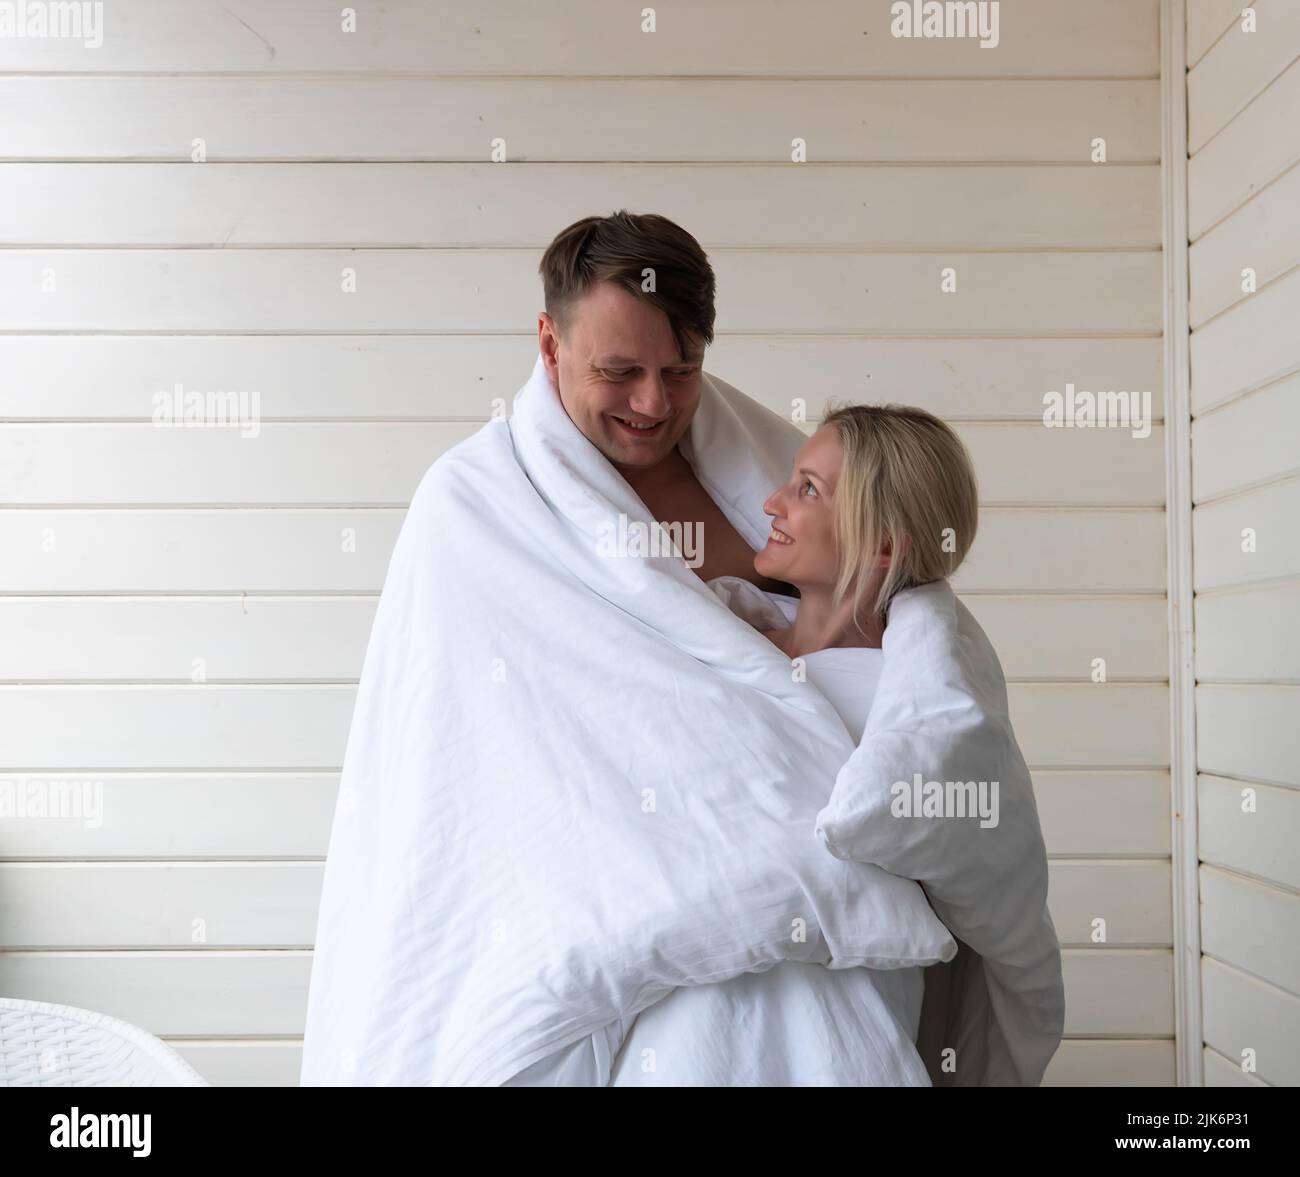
0, 0, 1175, 1085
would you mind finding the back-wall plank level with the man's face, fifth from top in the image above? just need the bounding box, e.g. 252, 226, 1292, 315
0, 332, 1164, 421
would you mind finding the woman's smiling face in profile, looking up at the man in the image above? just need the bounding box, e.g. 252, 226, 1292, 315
754, 425, 842, 592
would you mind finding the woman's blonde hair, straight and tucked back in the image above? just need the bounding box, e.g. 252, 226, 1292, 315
823, 404, 979, 619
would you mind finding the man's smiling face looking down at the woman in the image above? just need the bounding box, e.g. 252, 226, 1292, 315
538, 282, 703, 469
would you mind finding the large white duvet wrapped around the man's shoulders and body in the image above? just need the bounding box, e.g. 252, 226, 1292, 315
302, 360, 957, 1085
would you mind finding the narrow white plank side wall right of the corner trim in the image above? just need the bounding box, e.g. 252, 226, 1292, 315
1187, 0, 1300, 1086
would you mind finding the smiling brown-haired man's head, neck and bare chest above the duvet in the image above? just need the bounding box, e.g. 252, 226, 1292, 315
538, 211, 794, 593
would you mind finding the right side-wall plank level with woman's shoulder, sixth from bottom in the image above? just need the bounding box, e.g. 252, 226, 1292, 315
1196, 581, 1300, 684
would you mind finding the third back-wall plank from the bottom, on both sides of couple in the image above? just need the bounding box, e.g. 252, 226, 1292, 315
0, 861, 1170, 949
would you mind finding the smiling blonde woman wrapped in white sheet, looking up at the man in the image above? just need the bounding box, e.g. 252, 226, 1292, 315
507, 406, 978, 1087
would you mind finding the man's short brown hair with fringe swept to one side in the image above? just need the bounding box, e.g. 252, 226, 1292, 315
538, 209, 716, 360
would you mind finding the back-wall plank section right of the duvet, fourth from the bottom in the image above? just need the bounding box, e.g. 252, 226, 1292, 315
1034, 770, 1170, 858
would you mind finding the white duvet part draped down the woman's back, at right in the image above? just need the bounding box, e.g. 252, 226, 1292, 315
816, 580, 1065, 1086
